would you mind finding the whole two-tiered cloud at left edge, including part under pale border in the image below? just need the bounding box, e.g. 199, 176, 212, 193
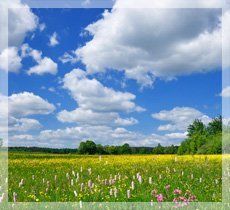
0, 92, 49, 136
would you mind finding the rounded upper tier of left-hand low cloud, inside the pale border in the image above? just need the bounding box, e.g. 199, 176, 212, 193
8, 92, 55, 118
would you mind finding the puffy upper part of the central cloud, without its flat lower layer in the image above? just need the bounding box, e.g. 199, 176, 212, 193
63, 69, 143, 112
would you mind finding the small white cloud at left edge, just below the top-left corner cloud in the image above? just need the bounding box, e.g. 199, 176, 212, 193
0, 47, 22, 72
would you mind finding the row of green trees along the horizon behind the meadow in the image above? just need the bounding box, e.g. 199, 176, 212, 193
8, 116, 225, 155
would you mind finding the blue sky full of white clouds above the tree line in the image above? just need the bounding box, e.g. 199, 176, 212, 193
0, 1, 230, 148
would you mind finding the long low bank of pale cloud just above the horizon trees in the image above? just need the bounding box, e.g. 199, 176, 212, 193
10, 125, 189, 148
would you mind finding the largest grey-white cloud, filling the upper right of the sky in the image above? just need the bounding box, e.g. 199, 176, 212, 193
72, 4, 221, 85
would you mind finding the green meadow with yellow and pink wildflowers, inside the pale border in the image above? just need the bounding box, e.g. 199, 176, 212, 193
9, 152, 222, 203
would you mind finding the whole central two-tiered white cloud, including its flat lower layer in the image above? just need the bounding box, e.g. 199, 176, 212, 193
57, 69, 141, 126
